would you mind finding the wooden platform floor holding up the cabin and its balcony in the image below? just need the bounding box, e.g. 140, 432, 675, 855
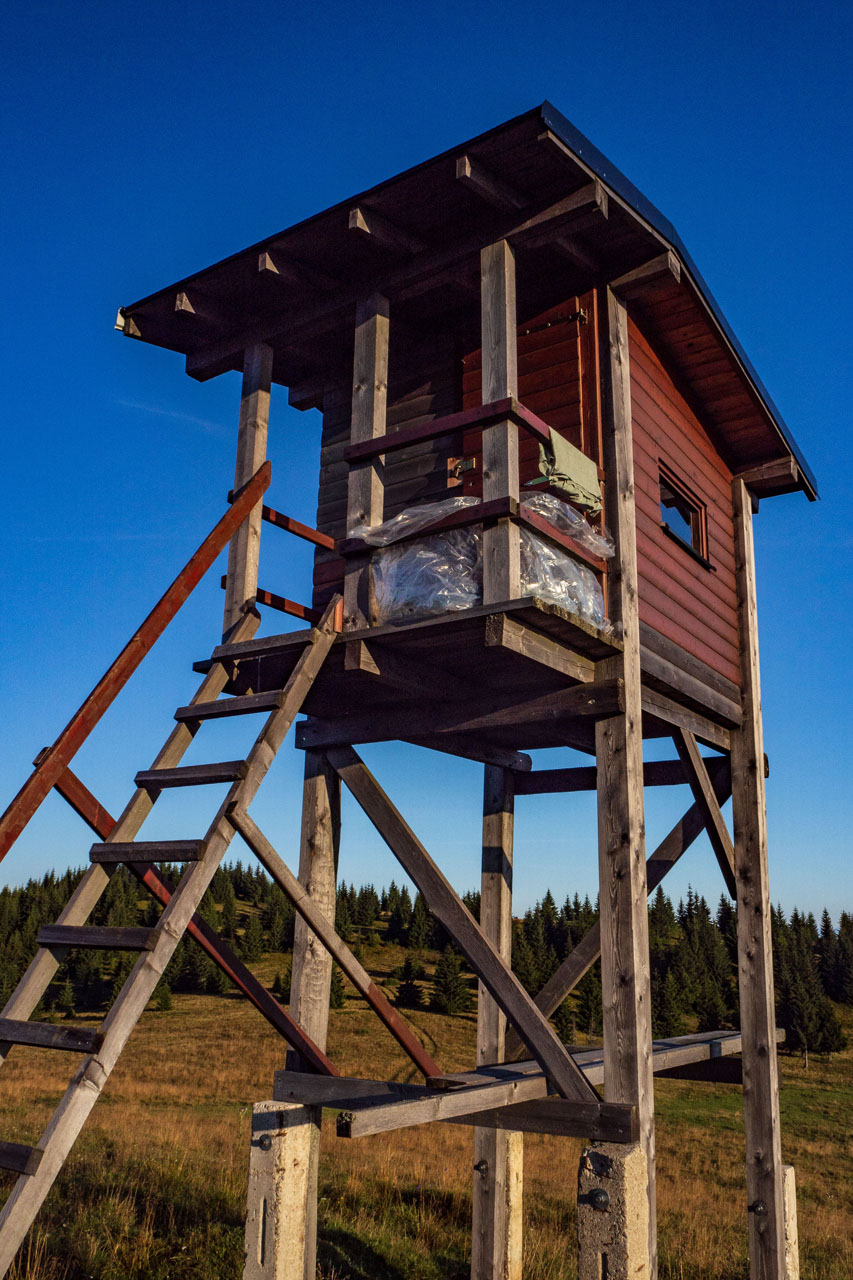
196, 596, 740, 768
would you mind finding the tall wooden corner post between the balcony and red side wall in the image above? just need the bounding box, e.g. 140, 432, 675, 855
596, 289, 657, 1277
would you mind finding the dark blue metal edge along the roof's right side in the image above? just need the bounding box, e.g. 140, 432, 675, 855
539, 101, 817, 498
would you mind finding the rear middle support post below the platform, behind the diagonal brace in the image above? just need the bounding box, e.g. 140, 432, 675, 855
471, 764, 524, 1280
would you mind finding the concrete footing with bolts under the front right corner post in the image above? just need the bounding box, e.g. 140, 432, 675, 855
578, 1143, 651, 1280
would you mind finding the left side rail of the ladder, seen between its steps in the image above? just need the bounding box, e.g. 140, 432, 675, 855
0, 613, 260, 1064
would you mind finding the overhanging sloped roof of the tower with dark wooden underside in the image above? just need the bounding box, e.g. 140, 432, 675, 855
117, 102, 816, 498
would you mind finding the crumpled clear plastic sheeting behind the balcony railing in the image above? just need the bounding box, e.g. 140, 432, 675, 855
352, 494, 613, 630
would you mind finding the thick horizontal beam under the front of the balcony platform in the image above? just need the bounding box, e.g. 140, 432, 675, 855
296, 678, 625, 750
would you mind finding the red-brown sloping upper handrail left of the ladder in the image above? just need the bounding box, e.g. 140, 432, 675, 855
0, 462, 272, 860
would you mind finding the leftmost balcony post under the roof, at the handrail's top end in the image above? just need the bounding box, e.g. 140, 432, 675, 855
222, 342, 273, 641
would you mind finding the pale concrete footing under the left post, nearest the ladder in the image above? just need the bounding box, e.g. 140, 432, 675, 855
243, 1102, 314, 1280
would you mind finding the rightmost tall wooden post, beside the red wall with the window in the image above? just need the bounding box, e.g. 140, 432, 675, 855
731, 480, 785, 1280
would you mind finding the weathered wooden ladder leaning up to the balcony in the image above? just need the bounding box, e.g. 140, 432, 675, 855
0, 596, 339, 1276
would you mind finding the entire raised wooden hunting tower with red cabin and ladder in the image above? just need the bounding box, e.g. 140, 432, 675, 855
0, 104, 815, 1280
